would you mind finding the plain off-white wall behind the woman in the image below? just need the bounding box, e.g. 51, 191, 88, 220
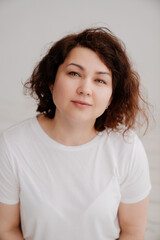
0, 0, 160, 240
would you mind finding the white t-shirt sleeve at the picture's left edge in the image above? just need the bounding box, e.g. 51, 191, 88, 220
0, 134, 19, 204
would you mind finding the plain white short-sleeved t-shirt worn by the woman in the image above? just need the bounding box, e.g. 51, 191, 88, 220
0, 117, 151, 240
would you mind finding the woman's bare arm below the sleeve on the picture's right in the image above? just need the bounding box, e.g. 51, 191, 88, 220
118, 197, 149, 240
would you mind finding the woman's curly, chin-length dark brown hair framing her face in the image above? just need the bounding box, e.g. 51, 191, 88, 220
24, 28, 148, 134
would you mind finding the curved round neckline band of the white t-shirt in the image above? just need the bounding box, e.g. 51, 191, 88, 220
32, 116, 107, 151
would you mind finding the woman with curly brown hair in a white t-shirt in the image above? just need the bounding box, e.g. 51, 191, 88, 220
0, 28, 151, 240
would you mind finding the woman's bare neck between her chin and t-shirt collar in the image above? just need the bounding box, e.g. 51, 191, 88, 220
38, 113, 97, 146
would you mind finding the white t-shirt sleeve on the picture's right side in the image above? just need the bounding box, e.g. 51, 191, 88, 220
121, 136, 151, 203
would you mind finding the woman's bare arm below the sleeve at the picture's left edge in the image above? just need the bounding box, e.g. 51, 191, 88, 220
0, 203, 23, 240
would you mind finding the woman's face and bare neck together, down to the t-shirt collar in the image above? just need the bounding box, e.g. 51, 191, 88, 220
45, 47, 112, 145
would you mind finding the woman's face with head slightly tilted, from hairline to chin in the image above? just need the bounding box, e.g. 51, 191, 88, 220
50, 47, 112, 124
